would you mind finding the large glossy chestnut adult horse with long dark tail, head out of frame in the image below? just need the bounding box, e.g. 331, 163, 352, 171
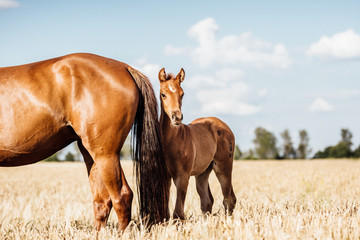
0, 54, 169, 230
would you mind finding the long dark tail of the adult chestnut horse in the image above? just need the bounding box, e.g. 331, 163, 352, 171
128, 67, 170, 224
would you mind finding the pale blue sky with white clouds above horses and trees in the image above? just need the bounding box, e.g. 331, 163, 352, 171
0, 0, 360, 156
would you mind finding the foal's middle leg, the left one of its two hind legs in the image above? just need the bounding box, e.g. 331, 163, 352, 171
195, 163, 214, 214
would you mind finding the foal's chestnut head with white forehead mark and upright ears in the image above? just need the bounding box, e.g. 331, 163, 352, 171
159, 68, 185, 125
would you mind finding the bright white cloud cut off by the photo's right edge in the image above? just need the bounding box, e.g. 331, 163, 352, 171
306, 29, 360, 59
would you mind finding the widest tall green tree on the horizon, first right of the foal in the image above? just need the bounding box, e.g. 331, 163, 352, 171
253, 127, 279, 159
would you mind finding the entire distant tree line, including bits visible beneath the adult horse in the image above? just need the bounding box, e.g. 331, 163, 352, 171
45, 127, 360, 162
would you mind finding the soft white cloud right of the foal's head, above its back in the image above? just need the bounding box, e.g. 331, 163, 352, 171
196, 82, 260, 115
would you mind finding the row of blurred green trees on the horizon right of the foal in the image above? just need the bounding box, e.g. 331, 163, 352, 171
234, 127, 360, 160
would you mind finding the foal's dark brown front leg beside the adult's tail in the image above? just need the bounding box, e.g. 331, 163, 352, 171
173, 176, 189, 219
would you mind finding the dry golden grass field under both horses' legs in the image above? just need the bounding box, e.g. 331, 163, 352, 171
0, 160, 360, 239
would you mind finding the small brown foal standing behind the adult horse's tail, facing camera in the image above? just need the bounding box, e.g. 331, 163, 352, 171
159, 68, 236, 219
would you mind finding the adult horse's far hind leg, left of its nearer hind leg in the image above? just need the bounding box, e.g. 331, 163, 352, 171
78, 141, 112, 231
